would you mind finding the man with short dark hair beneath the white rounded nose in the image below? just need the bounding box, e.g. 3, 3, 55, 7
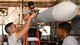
56, 22, 78, 45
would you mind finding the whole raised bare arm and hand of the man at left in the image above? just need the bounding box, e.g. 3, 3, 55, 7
16, 13, 36, 39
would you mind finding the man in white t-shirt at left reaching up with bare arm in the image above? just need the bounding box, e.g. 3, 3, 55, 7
5, 13, 36, 45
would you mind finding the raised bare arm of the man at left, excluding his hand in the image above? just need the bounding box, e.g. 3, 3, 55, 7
17, 18, 32, 39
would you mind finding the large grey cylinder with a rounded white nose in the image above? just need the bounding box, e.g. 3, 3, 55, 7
37, 1, 77, 22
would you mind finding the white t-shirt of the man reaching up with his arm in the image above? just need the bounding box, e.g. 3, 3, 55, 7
8, 33, 22, 45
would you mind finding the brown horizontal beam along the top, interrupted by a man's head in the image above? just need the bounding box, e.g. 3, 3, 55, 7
0, 1, 57, 7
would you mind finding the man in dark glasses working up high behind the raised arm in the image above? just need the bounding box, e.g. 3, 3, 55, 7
23, 1, 35, 21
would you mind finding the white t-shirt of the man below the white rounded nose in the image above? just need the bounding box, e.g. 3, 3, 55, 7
62, 36, 78, 45
